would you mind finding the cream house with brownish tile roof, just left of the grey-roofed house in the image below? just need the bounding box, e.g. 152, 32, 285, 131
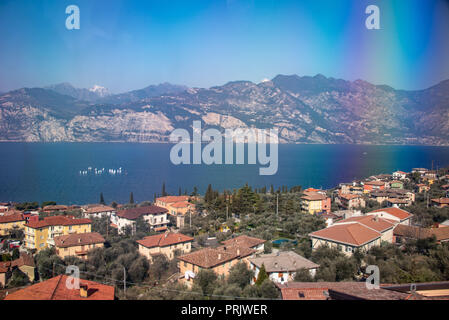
178, 246, 256, 286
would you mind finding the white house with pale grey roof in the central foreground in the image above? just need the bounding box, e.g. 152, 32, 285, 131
249, 251, 320, 284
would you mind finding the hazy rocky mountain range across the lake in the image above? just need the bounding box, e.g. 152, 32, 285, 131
0, 75, 449, 145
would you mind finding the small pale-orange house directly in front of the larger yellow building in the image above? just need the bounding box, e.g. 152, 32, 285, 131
54, 232, 105, 260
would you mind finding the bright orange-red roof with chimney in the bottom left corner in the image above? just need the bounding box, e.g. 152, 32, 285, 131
5, 275, 115, 300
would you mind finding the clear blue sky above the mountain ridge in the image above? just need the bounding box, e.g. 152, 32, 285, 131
0, 0, 449, 93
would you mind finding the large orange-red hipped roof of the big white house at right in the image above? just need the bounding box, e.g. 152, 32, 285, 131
309, 223, 381, 246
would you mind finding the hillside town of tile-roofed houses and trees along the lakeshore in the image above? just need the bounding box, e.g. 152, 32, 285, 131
0, 168, 449, 300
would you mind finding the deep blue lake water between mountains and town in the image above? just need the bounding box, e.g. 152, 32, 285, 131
0, 143, 449, 204
